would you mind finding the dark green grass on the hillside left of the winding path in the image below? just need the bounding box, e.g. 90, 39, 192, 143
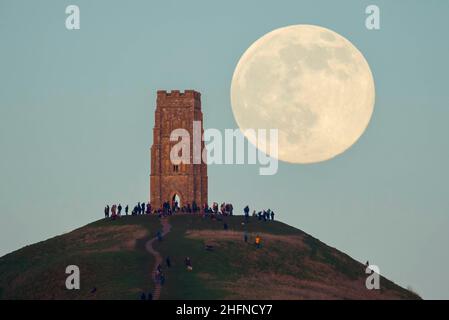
0, 216, 160, 299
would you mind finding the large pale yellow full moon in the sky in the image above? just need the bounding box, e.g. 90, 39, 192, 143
231, 25, 375, 163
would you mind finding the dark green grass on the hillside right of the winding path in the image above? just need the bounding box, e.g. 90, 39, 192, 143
156, 215, 411, 299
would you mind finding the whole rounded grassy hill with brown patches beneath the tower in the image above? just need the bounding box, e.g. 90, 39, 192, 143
0, 215, 419, 299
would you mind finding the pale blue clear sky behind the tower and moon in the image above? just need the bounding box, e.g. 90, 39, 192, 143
0, 0, 449, 298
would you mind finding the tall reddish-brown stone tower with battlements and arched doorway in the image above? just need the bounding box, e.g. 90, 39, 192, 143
150, 90, 207, 209
